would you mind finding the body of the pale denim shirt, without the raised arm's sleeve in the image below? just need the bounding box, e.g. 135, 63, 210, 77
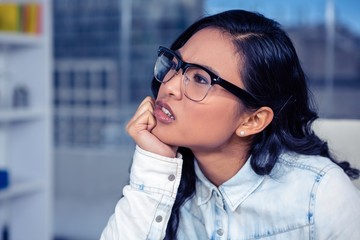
178, 154, 360, 240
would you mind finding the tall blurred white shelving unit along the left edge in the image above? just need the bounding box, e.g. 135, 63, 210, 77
0, 0, 53, 240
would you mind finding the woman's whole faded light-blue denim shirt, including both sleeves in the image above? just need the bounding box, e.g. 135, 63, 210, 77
101, 147, 360, 240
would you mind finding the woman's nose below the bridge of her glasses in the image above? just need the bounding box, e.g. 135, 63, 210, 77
159, 69, 183, 99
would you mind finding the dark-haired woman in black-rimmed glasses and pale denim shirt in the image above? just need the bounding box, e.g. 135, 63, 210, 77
101, 10, 360, 240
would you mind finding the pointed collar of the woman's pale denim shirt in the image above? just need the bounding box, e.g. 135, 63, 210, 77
195, 157, 265, 211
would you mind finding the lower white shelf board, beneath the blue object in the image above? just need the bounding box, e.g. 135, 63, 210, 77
0, 180, 45, 201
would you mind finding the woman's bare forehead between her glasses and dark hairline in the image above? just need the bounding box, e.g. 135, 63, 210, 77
179, 28, 242, 86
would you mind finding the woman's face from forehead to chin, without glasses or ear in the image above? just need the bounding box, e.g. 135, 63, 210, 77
152, 28, 249, 151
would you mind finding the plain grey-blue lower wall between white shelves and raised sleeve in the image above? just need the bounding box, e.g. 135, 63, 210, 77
54, 147, 134, 240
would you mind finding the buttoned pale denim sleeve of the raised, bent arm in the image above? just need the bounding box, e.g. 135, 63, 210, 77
100, 146, 182, 240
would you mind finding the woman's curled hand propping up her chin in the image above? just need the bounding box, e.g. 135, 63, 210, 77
126, 97, 177, 157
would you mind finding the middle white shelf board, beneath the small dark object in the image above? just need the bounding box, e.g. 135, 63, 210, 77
0, 109, 44, 124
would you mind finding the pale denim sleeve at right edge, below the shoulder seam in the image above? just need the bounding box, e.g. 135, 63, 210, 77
314, 167, 360, 239
